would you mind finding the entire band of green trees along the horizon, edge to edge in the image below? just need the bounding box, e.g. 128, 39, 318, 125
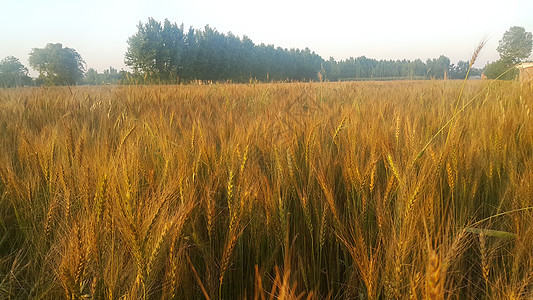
0, 18, 532, 87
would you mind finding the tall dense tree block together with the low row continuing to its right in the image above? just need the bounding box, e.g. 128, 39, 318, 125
125, 18, 480, 83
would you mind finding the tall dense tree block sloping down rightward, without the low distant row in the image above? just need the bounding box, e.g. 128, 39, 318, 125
125, 18, 323, 83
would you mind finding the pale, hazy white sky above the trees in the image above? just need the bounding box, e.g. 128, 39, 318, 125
0, 0, 533, 75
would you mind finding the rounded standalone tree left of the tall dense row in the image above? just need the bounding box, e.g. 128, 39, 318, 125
29, 43, 85, 85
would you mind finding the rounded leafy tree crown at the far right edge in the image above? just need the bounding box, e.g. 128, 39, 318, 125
496, 26, 533, 65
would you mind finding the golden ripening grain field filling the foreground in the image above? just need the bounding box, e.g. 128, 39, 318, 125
0, 81, 533, 299
